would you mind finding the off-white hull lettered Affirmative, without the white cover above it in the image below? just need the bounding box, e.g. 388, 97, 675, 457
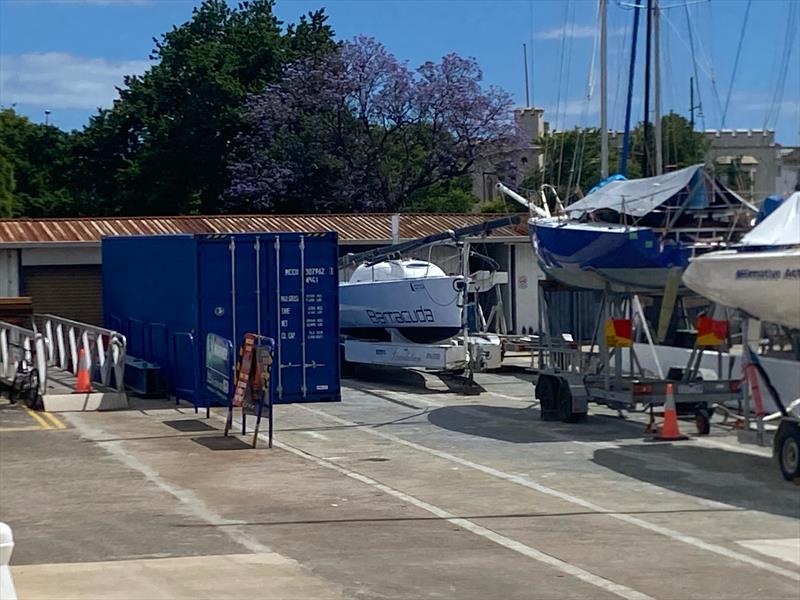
683, 248, 800, 328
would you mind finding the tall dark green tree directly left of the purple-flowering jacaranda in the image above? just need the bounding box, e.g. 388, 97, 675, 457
74, 0, 334, 215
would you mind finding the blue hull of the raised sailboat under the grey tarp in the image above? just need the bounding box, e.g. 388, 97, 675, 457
529, 219, 690, 294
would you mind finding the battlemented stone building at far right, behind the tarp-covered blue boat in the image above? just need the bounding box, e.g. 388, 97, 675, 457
705, 129, 781, 201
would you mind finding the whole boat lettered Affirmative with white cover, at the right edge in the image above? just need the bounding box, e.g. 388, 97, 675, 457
683, 192, 800, 328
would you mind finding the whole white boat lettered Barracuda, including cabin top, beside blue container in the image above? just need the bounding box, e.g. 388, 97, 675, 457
339, 259, 465, 344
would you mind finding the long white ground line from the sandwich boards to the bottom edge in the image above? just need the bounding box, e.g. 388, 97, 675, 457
214, 415, 655, 600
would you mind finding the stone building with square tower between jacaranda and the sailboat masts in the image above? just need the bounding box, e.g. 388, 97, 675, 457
470, 108, 548, 201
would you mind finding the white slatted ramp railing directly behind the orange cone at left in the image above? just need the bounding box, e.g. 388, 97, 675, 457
33, 314, 128, 392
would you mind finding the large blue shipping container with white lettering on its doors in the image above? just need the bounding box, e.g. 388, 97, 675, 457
103, 232, 341, 404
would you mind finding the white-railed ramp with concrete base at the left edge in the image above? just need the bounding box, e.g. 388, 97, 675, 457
0, 315, 128, 412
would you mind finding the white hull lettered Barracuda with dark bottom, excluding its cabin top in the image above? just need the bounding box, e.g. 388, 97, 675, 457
339, 277, 463, 343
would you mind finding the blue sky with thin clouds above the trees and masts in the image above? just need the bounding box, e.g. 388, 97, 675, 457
0, 0, 800, 145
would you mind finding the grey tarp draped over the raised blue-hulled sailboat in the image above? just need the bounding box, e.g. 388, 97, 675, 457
567, 165, 706, 219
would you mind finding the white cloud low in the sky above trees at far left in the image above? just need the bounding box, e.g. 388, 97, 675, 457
0, 52, 150, 109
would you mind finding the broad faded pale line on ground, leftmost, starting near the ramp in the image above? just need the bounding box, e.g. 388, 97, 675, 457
66, 414, 272, 554
